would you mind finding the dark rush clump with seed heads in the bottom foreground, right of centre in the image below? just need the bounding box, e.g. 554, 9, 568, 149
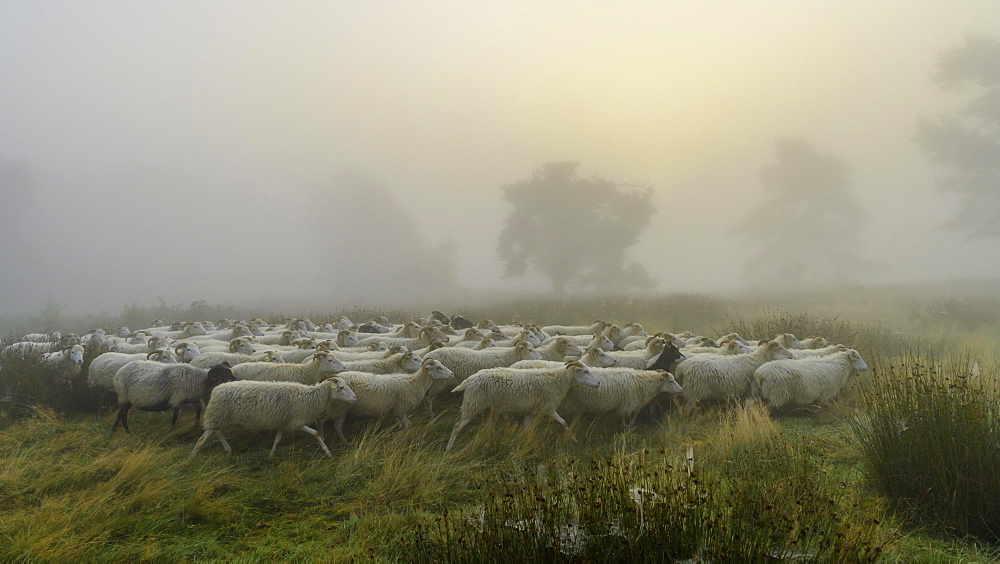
406, 404, 892, 562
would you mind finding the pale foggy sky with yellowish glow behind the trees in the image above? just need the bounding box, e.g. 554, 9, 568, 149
0, 0, 1000, 313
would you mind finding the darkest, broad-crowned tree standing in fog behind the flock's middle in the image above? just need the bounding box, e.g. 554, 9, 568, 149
497, 162, 656, 293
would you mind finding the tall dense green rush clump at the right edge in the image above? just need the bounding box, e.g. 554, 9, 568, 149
852, 352, 1000, 542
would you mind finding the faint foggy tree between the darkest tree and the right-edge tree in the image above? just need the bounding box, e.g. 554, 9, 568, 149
735, 139, 872, 285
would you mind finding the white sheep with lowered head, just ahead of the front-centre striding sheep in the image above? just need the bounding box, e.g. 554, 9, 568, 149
559, 368, 683, 427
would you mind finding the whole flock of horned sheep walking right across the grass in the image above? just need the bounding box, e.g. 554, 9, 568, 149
0, 311, 867, 456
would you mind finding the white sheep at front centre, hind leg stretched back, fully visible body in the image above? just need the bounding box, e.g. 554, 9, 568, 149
445, 361, 600, 452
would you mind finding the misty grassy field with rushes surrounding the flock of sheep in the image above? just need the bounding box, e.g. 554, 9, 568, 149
0, 288, 1000, 562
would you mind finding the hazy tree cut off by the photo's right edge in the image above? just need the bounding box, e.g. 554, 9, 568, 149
917, 37, 1000, 237
